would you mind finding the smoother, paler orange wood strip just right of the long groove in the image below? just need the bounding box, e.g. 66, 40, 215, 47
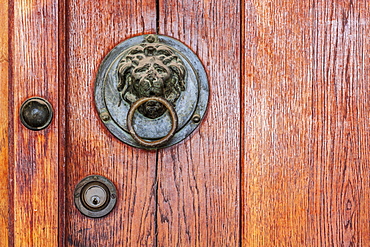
242, 0, 312, 246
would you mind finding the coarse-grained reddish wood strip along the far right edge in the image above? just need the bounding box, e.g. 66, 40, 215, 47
308, 0, 370, 246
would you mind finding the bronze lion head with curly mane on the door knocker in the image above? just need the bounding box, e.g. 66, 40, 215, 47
117, 43, 186, 119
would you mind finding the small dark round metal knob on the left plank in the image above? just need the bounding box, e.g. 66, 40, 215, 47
20, 97, 53, 130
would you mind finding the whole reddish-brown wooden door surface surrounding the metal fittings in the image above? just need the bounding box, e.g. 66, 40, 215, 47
0, 0, 370, 247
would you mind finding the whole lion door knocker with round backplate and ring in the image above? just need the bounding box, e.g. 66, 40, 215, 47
95, 34, 209, 149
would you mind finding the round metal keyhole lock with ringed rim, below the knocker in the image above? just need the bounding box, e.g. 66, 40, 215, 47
74, 175, 117, 218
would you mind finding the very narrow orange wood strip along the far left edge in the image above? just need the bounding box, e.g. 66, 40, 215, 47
0, 0, 9, 247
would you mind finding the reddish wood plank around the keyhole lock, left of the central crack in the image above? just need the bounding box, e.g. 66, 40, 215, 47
66, 0, 156, 247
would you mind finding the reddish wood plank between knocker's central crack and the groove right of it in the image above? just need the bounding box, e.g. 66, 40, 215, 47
157, 0, 240, 246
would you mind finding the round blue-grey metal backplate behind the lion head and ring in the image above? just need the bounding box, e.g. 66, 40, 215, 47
95, 34, 209, 149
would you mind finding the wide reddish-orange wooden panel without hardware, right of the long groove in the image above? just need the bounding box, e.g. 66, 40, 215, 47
242, 0, 370, 246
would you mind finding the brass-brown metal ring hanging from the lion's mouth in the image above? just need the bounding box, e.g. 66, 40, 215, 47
127, 97, 178, 147
